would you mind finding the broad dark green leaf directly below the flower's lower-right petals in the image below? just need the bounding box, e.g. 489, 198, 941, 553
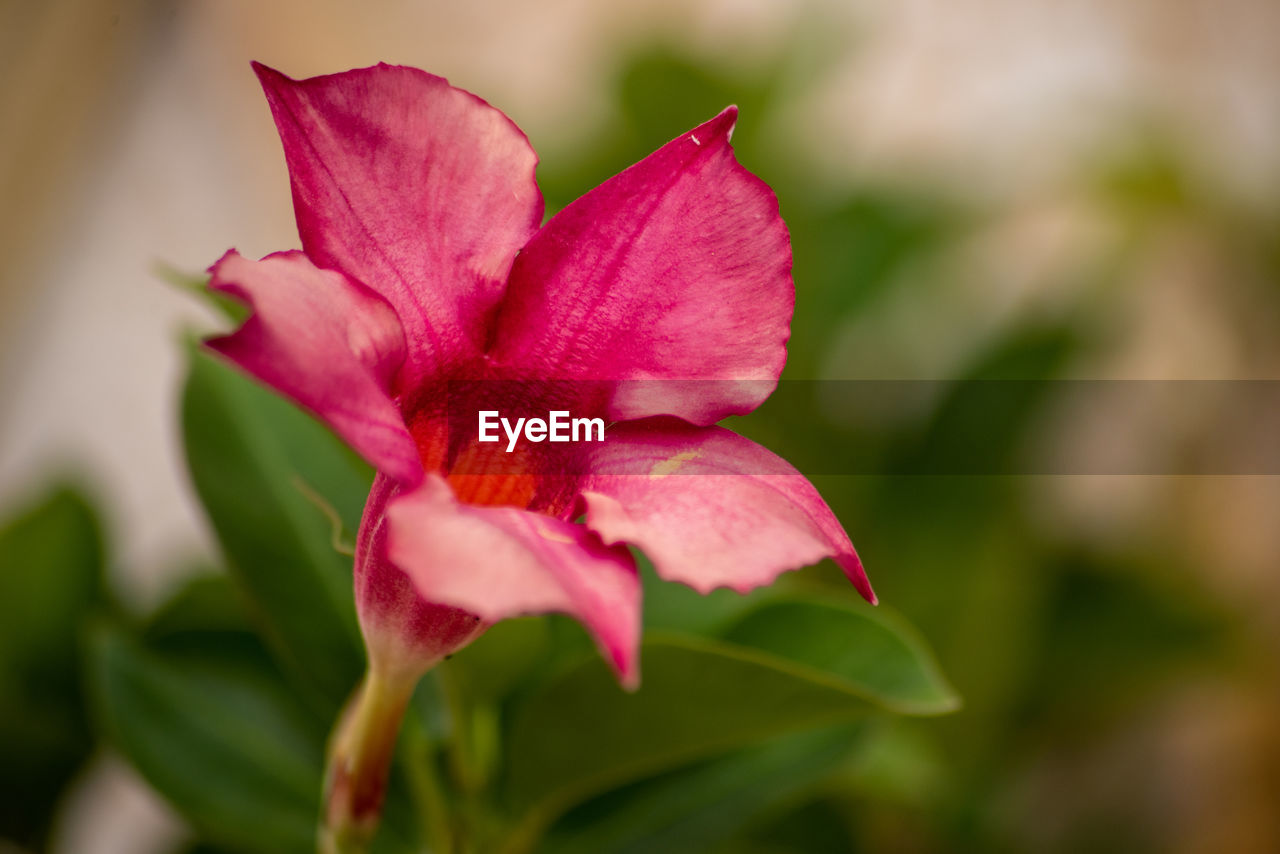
507, 622, 943, 832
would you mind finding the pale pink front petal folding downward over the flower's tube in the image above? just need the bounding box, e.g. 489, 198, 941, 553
387, 475, 640, 688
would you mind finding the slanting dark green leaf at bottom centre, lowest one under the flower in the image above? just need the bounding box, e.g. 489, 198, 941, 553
539, 725, 860, 854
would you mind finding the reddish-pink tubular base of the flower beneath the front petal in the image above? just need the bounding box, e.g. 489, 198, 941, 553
355, 475, 489, 677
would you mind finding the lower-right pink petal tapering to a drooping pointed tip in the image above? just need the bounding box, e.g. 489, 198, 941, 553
580, 419, 876, 603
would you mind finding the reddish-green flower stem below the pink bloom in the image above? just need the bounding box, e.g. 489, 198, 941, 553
317, 667, 419, 854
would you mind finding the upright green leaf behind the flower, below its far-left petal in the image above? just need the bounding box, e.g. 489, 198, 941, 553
182, 348, 371, 713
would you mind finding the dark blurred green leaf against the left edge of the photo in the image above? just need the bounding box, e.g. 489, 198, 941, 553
0, 487, 104, 848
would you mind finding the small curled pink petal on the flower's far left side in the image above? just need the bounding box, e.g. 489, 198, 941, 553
206, 250, 422, 484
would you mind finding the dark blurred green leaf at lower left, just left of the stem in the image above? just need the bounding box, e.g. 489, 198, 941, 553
90, 626, 323, 854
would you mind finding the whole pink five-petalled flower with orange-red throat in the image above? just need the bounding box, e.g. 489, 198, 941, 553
209, 65, 874, 684
